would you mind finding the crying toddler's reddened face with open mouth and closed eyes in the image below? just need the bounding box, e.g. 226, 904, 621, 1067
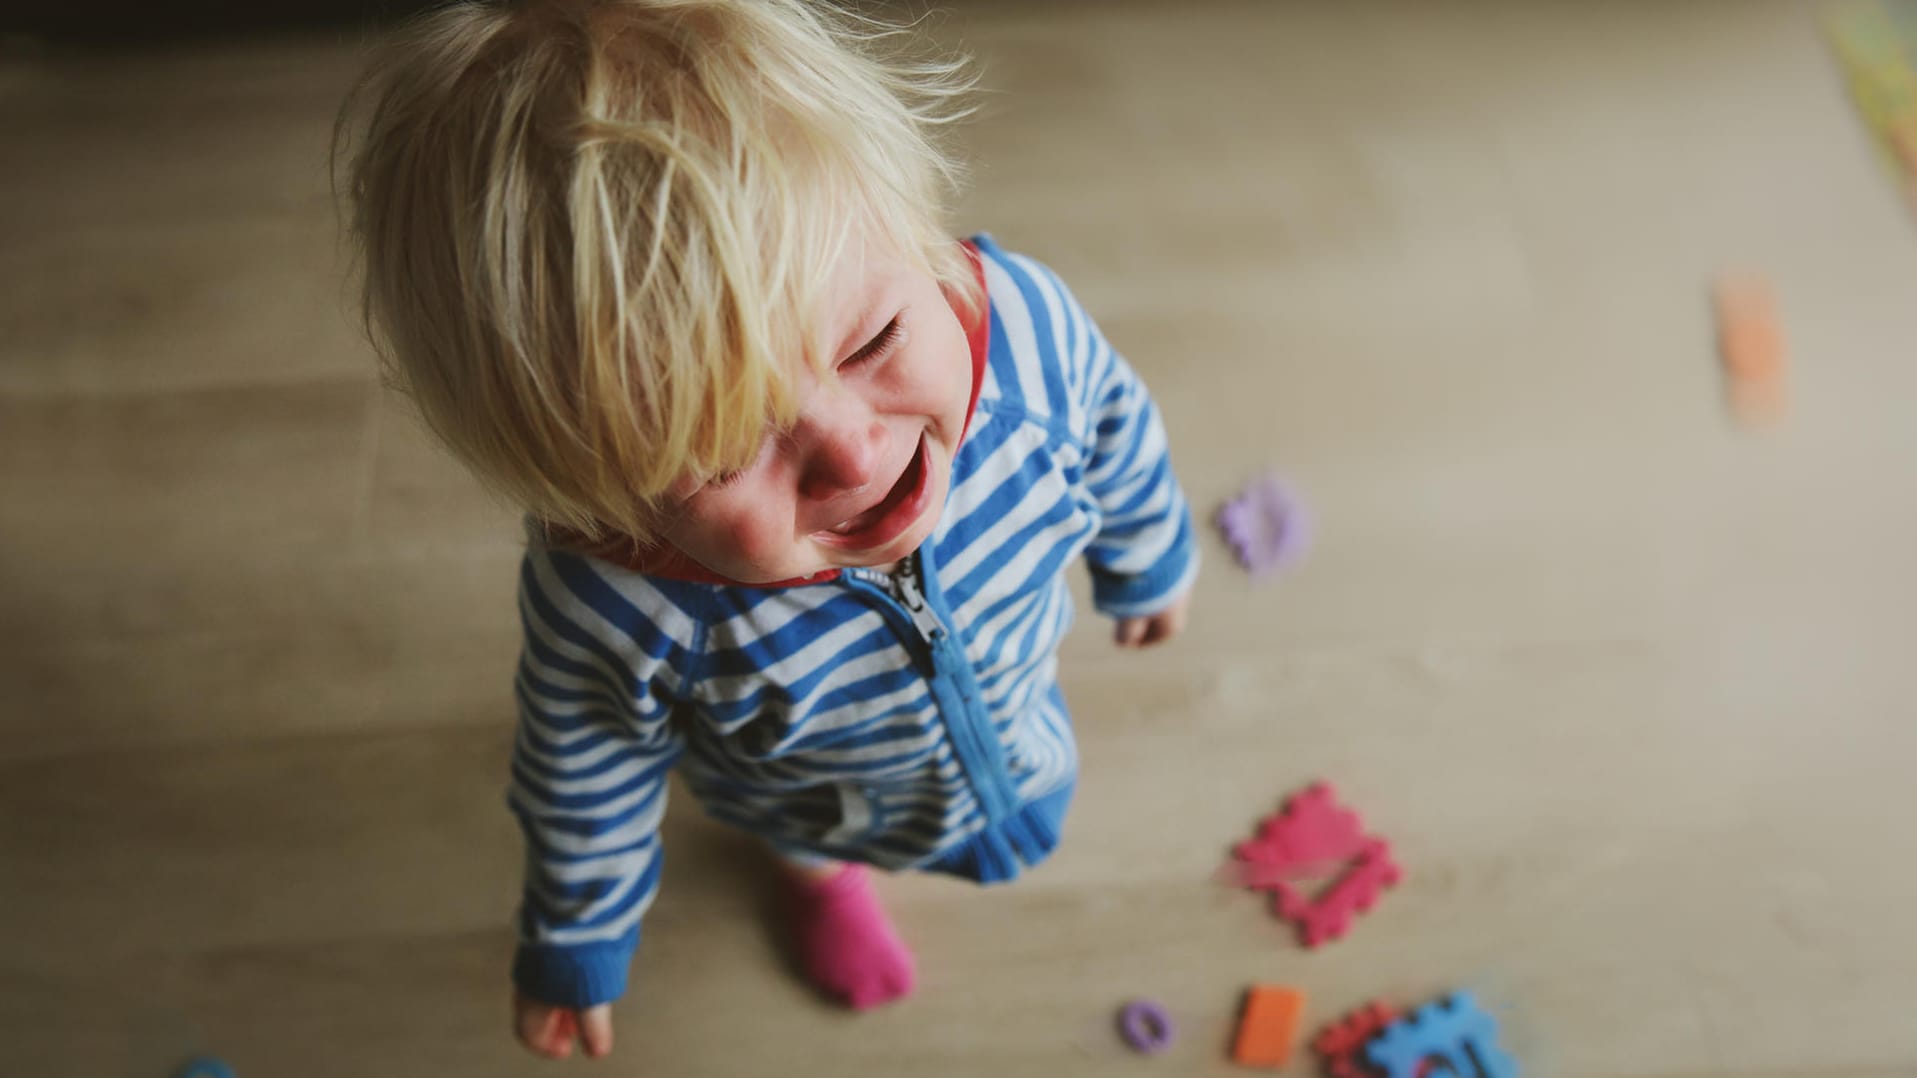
665, 246, 972, 583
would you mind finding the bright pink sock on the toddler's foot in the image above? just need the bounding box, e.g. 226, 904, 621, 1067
794, 865, 912, 1011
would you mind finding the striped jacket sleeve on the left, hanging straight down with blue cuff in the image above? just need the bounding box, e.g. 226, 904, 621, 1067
508, 545, 696, 1007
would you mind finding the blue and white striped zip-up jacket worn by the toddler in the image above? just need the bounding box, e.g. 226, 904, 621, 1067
510, 236, 1198, 1007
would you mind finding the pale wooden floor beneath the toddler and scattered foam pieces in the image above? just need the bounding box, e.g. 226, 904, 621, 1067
0, 0, 1917, 1078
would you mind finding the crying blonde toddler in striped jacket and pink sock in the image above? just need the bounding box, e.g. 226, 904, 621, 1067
341, 0, 1196, 1057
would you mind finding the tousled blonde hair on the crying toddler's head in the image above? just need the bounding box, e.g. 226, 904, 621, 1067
335, 0, 982, 543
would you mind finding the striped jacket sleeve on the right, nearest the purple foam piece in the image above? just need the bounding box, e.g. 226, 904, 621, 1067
1012, 255, 1198, 618
